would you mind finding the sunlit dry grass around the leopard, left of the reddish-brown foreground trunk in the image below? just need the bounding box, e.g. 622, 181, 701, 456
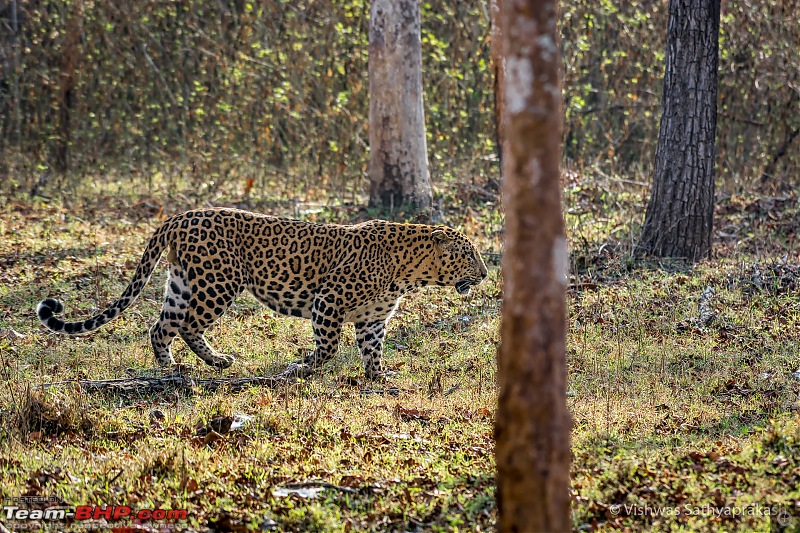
0, 192, 499, 531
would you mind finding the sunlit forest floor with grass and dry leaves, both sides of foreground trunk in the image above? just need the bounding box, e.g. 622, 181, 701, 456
0, 174, 800, 532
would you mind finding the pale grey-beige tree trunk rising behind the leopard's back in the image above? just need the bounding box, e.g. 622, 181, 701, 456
369, 0, 431, 211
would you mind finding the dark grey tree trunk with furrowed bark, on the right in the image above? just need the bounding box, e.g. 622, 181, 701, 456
639, 0, 720, 262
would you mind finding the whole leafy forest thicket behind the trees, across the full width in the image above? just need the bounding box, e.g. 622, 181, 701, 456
0, 0, 800, 202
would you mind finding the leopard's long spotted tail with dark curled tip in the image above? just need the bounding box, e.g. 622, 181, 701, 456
36, 220, 170, 335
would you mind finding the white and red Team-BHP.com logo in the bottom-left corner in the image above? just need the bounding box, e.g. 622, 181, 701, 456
3, 505, 188, 521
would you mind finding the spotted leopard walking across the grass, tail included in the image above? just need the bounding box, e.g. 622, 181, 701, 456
37, 208, 488, 379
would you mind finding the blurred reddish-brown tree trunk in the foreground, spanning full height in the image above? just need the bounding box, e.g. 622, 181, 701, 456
495, 0, 571, 532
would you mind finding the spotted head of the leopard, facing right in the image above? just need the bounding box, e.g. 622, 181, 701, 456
430, 226, 488, 294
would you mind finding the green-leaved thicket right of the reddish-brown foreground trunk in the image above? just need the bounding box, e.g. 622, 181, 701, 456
561, 0, 800, 190
